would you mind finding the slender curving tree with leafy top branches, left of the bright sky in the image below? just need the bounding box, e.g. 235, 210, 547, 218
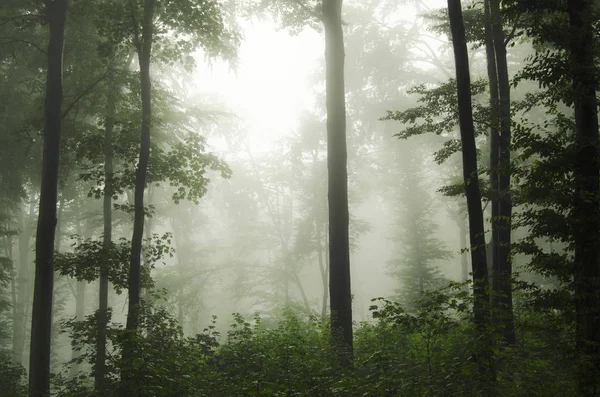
109, 0, 235, 396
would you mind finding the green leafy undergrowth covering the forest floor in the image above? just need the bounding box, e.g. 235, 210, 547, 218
0, 284, 575, 397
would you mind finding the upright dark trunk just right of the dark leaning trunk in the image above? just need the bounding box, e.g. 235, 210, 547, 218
486, 0, 516, 345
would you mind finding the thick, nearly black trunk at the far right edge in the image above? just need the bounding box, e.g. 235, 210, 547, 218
567, 0, 600, 397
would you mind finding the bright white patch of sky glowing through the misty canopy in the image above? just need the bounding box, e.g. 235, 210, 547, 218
194, 20, 324, 152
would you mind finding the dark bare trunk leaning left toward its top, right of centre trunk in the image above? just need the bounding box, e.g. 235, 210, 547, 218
448, 0, 493, 390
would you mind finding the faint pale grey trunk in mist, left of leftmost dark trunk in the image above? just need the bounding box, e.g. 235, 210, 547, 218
12, 198, 36, 364
